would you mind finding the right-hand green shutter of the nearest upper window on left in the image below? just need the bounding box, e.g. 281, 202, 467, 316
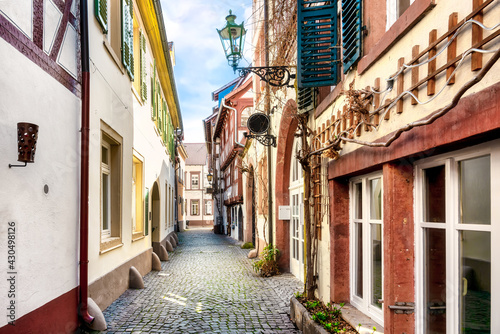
121, 0, 134, 80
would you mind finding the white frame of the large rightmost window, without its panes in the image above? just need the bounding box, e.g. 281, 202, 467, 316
414, 140, 500, 334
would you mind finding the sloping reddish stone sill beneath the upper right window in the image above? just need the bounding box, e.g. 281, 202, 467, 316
358, 0, 436, 74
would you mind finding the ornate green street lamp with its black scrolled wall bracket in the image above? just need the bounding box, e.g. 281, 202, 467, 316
217, 10, 295, 88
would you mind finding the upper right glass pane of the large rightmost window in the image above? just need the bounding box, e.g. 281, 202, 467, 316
458, 156, 491, 225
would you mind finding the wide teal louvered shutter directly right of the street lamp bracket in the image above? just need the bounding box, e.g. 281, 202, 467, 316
297, 0, 340, 88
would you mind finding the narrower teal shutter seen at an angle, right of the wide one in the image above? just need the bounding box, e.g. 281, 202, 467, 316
342, 0, 362, 73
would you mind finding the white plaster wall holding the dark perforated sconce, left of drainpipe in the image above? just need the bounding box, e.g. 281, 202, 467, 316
0, 39, 81, 327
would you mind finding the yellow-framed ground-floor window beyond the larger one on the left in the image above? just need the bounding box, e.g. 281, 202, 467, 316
132, 155, 144, 239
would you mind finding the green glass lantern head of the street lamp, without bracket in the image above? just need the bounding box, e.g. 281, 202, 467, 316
217, 11, 247, 71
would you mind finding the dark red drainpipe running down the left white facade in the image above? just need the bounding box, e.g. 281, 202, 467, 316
79, 0, 94, 324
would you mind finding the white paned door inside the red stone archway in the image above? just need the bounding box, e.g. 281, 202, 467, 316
289, 139, 304, 282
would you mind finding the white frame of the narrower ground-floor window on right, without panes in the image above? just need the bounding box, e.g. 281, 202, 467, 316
349, 171, 385, 326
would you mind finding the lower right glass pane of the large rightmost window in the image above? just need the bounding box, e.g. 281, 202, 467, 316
460, 231, 491, 334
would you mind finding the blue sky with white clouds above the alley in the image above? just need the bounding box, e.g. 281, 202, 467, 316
161, 0, 252, 143
